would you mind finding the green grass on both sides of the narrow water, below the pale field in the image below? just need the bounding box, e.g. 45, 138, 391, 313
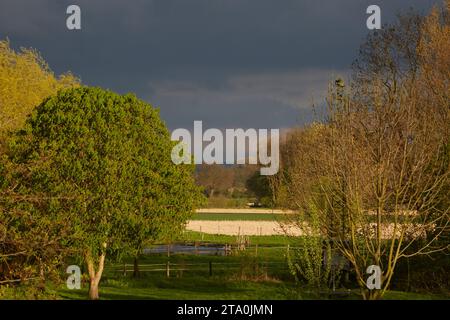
46, 232, 448, 300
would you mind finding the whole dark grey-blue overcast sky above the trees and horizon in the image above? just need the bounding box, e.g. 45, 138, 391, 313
0, 0, 436, 129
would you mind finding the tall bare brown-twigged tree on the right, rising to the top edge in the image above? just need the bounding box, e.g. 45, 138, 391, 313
278, 1, 450, 299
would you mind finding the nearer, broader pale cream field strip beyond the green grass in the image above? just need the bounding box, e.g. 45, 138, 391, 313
186, 220, 426, 239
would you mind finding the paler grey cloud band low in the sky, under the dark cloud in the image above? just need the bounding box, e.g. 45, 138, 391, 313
149, 69, 346, 127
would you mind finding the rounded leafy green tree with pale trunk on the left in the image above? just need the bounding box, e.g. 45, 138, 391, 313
4, 87, 201, 299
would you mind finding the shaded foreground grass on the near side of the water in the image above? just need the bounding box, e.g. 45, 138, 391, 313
57, 277, 449, 300
